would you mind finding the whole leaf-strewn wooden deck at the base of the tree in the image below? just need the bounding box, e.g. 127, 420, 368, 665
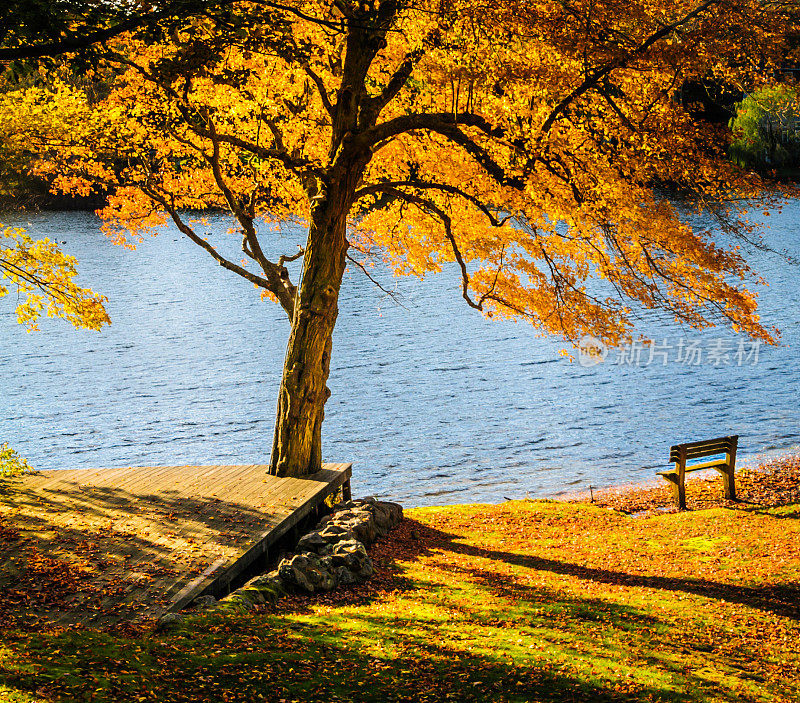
0, 464, 351, 625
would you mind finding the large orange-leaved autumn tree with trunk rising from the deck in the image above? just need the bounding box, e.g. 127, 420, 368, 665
8, 0, 792, 476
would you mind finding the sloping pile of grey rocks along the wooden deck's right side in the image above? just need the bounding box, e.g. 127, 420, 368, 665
197, 498, 403, 610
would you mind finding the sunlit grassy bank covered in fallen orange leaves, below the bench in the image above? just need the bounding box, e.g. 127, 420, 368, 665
0, 464, 800, 703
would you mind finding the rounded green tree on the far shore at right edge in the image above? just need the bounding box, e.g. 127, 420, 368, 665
730, 85, 800, 169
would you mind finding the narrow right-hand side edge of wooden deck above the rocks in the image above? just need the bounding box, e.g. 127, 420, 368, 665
165, 464, 353, 613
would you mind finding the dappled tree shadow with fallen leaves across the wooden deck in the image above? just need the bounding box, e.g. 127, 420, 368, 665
0, 472, 296, 627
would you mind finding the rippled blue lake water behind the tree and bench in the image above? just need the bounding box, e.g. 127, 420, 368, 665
0, 202, 800, 505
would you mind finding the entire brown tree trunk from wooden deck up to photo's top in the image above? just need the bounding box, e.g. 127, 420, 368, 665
270, 17, 382, 476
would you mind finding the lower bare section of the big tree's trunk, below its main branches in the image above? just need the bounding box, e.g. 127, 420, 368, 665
269, 199, 349, 476
